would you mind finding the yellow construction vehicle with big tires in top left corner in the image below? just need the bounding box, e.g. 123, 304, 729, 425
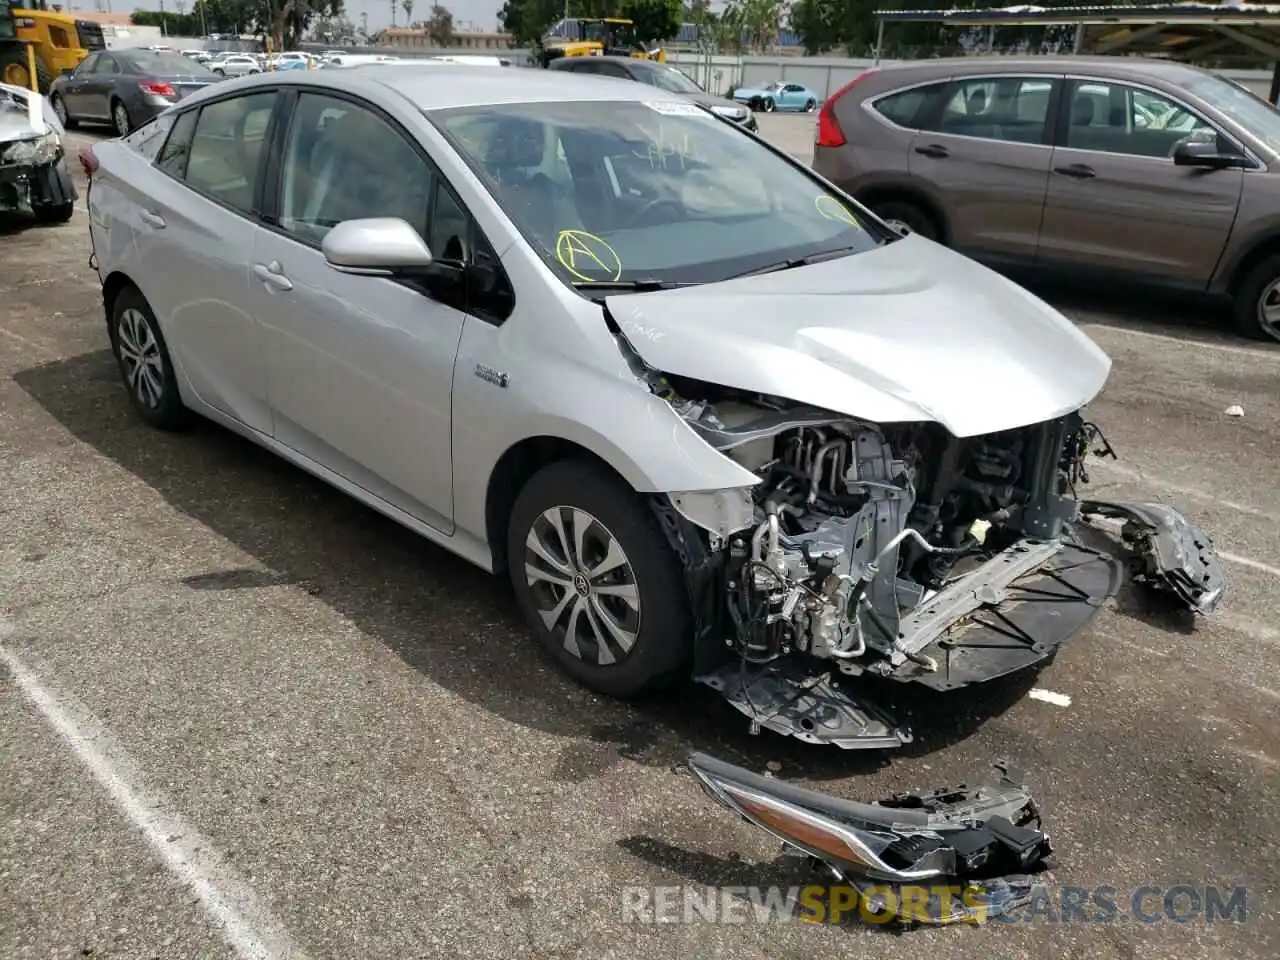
0, 0, 106, 93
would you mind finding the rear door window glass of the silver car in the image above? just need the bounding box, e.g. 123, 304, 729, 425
181, 91, 275, 214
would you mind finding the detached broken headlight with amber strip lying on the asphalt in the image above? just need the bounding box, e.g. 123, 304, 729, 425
681, 754, 1052, 924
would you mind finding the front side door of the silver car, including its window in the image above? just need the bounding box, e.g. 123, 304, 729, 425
250, 92, 468, 532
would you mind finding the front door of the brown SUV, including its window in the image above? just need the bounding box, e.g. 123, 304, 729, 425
1039, 79, 1244, 287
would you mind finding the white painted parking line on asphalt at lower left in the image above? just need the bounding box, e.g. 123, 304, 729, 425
0, 632, 305, 960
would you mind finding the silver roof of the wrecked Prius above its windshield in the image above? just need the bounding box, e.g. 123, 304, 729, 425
183, 61, 689, 111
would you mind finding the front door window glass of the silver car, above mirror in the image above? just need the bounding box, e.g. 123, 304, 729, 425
280, 93, 435, 245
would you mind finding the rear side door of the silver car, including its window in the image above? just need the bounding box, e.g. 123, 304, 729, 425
138, 90, 276, 435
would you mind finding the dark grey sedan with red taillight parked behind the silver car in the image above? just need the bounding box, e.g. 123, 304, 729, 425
49, 49, 218, 137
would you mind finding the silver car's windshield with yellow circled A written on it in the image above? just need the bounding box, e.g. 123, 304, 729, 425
430, 100, 886, 293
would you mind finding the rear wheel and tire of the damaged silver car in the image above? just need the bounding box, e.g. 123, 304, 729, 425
109, 287, 187, 430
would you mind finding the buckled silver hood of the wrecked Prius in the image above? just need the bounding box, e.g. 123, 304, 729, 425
605, 236, 1111, 436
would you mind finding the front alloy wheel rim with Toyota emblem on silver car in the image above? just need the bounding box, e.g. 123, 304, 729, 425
525, 507, 640, 667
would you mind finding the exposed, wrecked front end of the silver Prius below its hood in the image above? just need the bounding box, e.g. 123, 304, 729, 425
652, 376, 1224, 748
